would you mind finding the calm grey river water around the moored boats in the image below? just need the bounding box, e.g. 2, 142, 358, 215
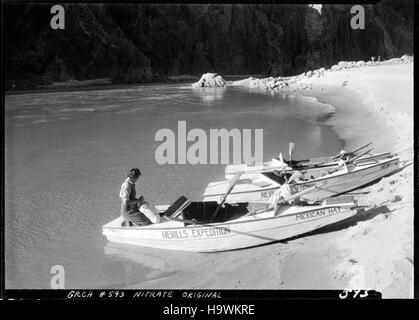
5, 84, 342, 289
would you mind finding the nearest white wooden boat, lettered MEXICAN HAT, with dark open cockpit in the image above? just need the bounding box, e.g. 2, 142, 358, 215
102, 198, 358, 252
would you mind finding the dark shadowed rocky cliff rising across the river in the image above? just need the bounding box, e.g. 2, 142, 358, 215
4, 0, 413, 88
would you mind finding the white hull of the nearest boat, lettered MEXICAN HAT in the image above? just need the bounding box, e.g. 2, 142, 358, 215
103, 203, 357, 252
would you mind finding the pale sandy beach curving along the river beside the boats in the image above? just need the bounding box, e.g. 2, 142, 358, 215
130, 61, 414, 298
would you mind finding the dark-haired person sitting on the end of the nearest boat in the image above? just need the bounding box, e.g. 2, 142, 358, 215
119, 168, 160, 226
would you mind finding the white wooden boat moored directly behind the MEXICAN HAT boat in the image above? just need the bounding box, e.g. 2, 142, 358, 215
204, 155, 400, 203
